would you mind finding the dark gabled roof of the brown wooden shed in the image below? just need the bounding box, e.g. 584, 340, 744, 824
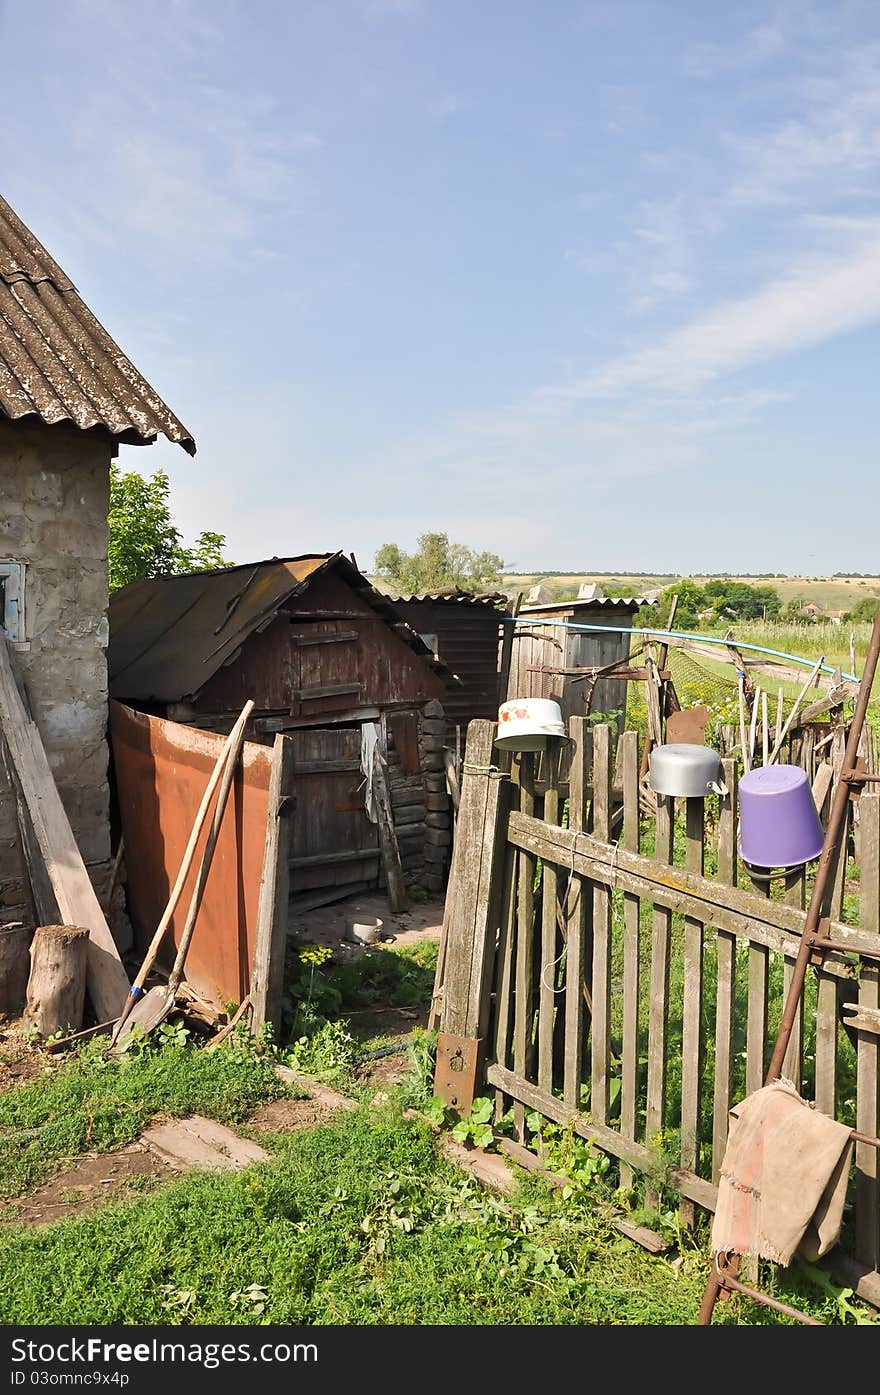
107, 552, 452, 702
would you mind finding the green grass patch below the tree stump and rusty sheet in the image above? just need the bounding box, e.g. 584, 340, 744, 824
0, 1039, 282, 1197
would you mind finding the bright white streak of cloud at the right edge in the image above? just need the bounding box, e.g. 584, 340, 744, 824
545, 230, 880, 398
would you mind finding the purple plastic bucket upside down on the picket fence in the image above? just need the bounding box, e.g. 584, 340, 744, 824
739, 766, 824, 868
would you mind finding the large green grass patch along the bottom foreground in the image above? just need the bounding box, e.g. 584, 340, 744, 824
0, 1076, 859, 1325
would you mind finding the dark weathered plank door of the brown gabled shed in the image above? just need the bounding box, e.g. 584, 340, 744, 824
290, 727, 379, 903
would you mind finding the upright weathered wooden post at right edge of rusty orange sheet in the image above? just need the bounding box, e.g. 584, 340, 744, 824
251, 735, 294, 1041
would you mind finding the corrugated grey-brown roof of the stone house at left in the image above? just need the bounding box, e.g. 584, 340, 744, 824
0, 198, 195, 455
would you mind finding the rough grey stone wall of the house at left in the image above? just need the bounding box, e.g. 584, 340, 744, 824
0, 423, 113, 919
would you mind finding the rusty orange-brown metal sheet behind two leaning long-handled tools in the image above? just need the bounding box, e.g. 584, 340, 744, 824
110, 702, 273, 1003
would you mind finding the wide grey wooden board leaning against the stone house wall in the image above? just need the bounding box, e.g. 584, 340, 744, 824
0, 638, 130, 1021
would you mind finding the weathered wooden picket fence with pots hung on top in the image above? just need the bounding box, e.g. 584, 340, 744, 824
435, 717, 880, 1303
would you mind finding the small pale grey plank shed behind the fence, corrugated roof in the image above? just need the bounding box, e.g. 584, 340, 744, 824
506, 597, 642, 731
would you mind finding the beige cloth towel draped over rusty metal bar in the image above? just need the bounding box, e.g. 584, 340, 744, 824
711, 1080, 852, 1264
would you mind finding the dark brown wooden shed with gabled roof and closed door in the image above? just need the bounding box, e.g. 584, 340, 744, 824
109, 552, 456, 908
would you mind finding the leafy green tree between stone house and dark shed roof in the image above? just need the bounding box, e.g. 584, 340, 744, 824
107, 460, 232, 593
